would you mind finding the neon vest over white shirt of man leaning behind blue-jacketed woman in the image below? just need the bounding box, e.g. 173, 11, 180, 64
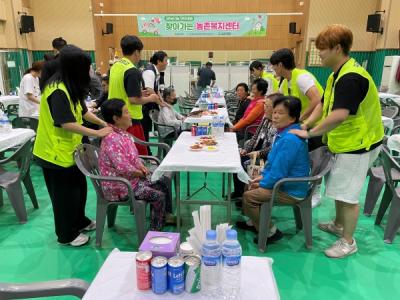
280, 68, 324, 114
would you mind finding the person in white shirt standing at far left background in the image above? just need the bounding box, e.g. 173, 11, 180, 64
18, 61, 44, 118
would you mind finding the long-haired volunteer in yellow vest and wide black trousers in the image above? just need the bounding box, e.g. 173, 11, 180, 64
33, 45, 112, 246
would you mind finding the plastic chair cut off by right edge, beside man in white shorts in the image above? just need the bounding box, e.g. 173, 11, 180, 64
375, 146, 400, 244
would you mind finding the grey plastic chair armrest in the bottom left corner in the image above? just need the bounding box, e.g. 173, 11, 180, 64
0, 279, 89, 300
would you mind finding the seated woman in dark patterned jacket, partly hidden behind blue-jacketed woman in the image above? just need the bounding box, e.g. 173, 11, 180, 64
231, 93, 283, 202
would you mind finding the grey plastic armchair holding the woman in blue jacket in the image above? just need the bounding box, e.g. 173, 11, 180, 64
258, 147, 333, 252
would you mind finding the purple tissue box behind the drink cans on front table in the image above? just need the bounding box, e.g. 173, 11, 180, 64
139, 231, 180, 258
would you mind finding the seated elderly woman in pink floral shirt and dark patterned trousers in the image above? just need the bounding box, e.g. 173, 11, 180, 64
99, 99, 173, 230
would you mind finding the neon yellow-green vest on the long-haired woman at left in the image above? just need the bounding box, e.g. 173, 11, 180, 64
33, 82, 83, 168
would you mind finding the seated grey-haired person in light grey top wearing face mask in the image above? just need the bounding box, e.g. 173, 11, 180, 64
158, 87, 185, 138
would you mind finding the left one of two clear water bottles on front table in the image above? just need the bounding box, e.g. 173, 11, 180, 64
201, 230, 221, 298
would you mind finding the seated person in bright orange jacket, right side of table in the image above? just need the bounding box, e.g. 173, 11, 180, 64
231, 78, 268, 141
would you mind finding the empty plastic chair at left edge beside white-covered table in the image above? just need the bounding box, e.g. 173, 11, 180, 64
0, 138, 39, 223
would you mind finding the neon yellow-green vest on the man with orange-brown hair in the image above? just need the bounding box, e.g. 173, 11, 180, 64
323, 58, 384, 153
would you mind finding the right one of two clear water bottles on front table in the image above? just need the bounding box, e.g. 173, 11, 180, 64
221, 229, 242, 299
